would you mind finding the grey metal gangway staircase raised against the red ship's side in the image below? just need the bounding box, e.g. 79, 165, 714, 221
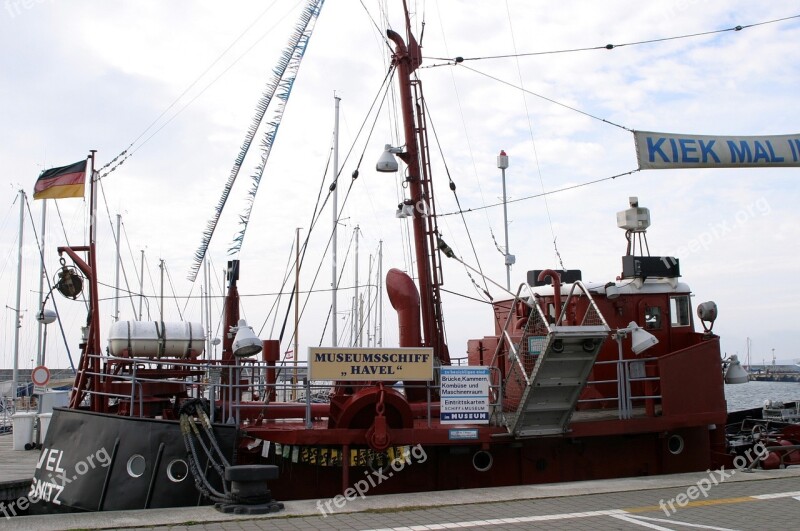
495, 282, 609, 437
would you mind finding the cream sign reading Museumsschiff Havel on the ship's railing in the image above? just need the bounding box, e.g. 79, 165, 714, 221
308, 347, 433, 382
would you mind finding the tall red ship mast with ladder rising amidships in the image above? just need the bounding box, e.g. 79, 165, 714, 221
386, 18, 450, 365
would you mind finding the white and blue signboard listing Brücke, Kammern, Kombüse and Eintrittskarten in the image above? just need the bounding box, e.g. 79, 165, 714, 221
439, 367, 489, 424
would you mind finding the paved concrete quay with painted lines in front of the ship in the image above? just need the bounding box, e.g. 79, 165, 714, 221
0, 460, 800, 531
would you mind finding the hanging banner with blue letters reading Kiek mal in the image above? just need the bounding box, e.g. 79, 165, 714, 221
633, 131, 800, 170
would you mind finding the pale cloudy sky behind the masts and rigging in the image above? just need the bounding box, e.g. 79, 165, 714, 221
0, 0, 800, 374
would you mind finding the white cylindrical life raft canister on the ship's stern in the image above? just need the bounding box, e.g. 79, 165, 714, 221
108, 321, 205, 358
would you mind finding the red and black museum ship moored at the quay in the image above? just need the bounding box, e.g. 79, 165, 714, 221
21, 3, 791, 513
